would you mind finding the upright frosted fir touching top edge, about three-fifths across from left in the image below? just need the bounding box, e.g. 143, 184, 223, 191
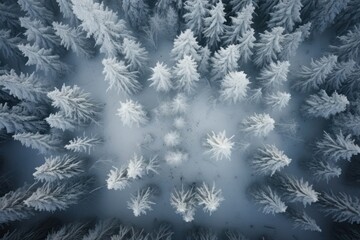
203, 0, 226, 49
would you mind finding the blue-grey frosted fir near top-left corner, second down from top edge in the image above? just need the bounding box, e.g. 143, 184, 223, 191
20, 17, 60, 50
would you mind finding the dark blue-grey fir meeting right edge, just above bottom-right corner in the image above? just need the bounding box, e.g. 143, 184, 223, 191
319, 192, 360, 224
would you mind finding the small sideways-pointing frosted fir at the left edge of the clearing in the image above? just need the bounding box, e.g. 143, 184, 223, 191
64, 136, 103, 154
